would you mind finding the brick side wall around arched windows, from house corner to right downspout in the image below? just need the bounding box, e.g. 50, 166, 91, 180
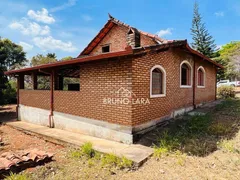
132, 48, 193, 125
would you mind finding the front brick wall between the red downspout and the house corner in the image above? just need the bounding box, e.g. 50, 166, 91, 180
54, 59, 132, 125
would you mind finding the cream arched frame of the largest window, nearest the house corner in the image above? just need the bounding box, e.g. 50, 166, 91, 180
150, 65, 167, 98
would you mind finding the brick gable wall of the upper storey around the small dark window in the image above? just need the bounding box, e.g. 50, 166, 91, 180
90, 25, 156, 55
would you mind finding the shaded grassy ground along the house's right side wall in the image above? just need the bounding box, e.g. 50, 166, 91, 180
136, 99, 240, 157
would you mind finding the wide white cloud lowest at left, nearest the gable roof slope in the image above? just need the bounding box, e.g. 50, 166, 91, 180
33, 36, 77, 52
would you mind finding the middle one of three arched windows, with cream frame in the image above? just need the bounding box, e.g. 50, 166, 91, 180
180, 61, 192, 87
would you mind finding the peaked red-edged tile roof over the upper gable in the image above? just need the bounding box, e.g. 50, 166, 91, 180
78, 14, 167, 57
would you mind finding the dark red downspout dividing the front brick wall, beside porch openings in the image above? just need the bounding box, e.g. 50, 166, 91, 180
39, 69, 54, 128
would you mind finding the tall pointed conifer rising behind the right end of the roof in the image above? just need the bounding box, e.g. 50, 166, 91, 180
191, 2, 216, 58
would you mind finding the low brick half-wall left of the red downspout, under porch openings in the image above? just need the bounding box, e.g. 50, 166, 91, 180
19, 89, 50, 110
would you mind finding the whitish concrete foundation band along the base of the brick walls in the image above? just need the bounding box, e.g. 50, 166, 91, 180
18, 105, 193, 144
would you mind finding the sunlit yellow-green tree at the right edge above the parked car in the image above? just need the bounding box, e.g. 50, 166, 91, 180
214, 42, 240, 80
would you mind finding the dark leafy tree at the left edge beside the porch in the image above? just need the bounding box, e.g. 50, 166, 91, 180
0, 38, 26, 105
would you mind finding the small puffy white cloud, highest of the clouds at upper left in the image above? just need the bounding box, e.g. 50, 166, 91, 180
27, 8, 55, 24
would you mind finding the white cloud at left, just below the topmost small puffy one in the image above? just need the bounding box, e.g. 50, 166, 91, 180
9, 19, 50, 36
